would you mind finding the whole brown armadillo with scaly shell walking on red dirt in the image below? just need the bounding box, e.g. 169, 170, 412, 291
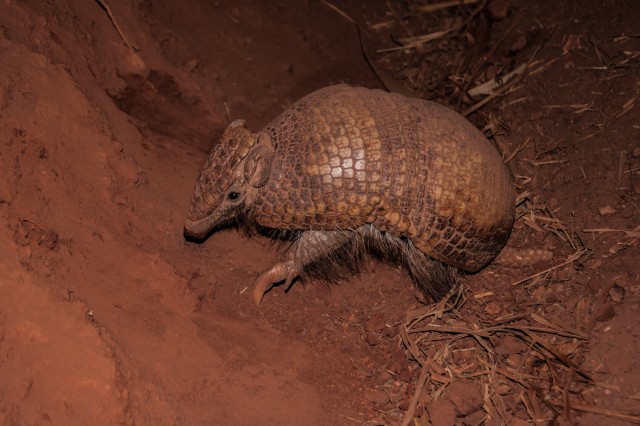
184, 85, 515, 304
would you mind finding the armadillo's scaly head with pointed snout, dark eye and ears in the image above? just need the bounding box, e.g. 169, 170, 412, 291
184, 120, 272, 239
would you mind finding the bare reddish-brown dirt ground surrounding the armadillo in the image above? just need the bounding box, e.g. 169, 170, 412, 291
0, 0, 640, 425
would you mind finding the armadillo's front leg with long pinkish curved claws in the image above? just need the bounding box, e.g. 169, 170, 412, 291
253, 231, 356, 306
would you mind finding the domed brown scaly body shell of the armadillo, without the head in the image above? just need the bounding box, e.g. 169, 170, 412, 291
253, 85, 515, 272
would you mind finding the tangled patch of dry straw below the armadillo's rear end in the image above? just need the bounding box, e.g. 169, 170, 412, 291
390, 287, 640, 424
